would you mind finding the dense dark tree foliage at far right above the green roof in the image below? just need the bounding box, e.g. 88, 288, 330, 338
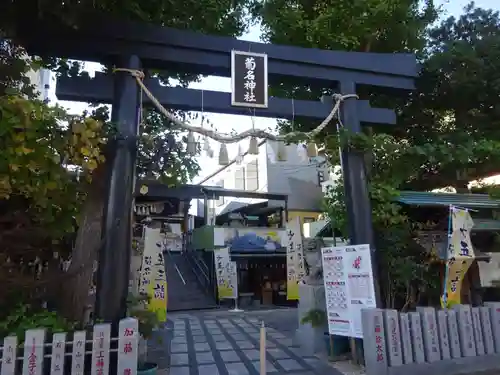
393, 4, 500, 194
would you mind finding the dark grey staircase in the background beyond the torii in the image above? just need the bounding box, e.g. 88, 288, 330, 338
165, 252, 217, 312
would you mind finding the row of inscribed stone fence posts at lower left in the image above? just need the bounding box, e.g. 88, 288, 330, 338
0, 318, 139, 375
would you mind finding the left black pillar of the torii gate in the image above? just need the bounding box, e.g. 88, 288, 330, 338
94, 56, 141, 322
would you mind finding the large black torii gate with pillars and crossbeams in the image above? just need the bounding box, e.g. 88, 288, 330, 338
18, 17, 417, 321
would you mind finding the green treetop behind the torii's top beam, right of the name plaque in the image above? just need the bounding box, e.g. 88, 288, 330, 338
251, 0, 437, 108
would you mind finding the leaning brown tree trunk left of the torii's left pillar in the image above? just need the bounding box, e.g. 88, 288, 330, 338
61, 165, 106, 324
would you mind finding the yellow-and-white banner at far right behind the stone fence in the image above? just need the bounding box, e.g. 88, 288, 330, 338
441, 208, 475, 307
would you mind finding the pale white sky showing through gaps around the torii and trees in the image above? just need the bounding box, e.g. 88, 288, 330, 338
50, 0, 500, 182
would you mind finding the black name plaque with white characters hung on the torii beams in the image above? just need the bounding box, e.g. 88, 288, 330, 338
231, 51, 268, 108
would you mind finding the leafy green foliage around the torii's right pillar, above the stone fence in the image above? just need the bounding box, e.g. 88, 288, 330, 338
325, 131, 446, 309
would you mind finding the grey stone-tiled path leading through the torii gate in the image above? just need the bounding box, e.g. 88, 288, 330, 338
165, 312, 340, 375
